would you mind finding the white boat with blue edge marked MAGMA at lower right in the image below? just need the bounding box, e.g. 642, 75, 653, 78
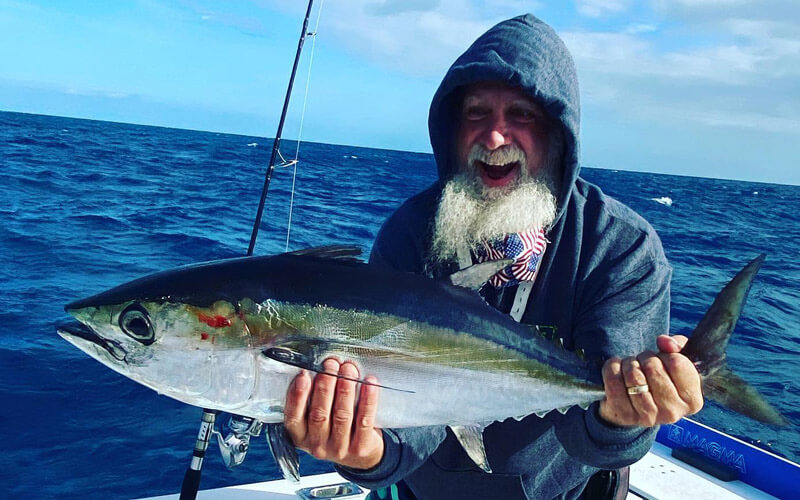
141, 418, 800, 500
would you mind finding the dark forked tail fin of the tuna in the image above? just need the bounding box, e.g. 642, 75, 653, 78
681, 254, 787, 425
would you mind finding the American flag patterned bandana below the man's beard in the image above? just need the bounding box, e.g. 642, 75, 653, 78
475, 229, 547, 288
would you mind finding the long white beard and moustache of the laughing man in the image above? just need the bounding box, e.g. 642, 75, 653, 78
431, 138, 561, 262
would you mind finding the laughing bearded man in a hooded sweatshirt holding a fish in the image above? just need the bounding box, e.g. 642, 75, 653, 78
286, 15, 702, 499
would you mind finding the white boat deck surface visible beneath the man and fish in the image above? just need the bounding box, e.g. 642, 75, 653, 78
144, 443, 775, 500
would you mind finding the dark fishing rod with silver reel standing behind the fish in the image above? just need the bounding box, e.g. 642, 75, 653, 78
180, 0, 316, 500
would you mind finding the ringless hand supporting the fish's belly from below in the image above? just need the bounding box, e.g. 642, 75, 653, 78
284, 358, 383, 469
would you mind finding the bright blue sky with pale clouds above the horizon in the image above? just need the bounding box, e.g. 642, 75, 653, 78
0, 0, 800, 185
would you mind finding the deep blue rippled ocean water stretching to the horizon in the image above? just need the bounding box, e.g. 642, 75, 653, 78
0, 112, 800, 498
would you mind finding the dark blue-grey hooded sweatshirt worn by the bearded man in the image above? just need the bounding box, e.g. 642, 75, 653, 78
339, 15, 671, 499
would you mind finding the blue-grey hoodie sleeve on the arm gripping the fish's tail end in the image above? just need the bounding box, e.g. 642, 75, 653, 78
556, 235, 671, 469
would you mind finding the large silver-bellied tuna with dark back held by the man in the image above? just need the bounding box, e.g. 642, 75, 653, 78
58, 246, 786, 478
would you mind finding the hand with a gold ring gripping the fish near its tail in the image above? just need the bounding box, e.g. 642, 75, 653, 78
600, 335, 703, 427
